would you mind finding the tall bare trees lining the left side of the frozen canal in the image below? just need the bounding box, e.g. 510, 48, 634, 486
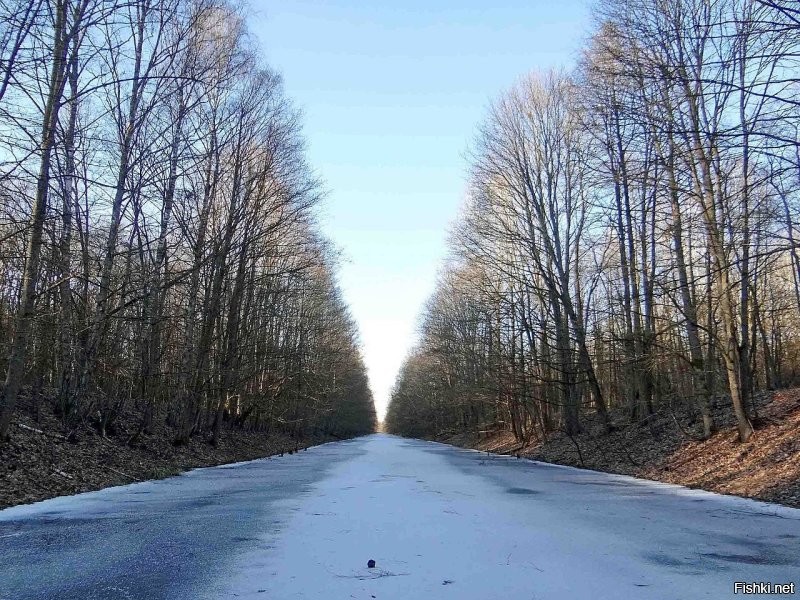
0, 0, 375, 444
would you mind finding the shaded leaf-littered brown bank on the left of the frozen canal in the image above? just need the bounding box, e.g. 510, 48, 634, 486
0, 398, 334, 508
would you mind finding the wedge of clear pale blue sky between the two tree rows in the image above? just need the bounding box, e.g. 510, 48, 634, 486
251, 0, 590, 416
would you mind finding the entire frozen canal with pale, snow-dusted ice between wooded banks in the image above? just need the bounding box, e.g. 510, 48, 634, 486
0, 435, 800, 600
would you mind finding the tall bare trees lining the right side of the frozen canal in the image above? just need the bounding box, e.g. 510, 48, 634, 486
387, 0, 800, 441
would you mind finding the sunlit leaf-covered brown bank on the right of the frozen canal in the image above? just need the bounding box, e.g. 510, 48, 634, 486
440, 388, 800, 507
